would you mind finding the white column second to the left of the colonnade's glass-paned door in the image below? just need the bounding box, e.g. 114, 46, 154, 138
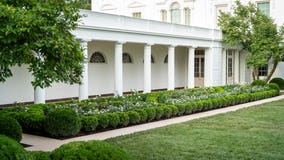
168, 46, 175, 90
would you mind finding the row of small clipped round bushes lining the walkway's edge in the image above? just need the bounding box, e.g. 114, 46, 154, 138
82, 90, 279, 131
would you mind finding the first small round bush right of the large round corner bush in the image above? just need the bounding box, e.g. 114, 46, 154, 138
81, 116, 98, 132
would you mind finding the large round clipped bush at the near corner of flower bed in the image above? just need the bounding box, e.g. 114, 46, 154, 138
44, 108, 81, 137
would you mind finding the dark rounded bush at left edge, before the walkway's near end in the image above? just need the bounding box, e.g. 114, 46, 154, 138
0, 115, 23, 142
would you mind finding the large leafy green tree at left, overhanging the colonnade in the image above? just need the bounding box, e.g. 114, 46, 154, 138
0, 0, 84, 88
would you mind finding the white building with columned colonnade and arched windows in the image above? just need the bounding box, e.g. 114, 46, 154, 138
0, 0, 284, 105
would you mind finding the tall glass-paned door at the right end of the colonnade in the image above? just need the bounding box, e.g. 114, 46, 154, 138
194, 50, 205, 87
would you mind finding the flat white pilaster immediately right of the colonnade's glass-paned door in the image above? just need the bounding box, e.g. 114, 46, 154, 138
204, 47, 213, 87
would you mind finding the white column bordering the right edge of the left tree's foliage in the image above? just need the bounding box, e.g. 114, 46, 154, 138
79, 41, 89, 101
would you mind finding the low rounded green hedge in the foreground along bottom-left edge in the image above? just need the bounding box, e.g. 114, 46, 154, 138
0, 135, 131, 160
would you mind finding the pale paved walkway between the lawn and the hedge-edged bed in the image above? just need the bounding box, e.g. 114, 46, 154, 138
21, 95, 284, 151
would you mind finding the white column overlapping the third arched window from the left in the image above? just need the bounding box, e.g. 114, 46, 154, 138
144, 44, 151, 93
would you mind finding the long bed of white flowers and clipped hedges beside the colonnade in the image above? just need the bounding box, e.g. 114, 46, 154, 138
0, 84, 279, 136
